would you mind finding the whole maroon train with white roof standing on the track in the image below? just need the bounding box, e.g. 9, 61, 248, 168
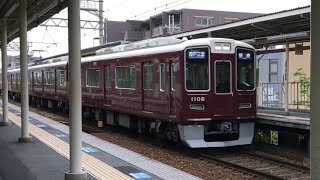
3, 38, 256, 148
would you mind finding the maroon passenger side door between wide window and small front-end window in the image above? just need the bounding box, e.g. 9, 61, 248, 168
141, 62, 153, 111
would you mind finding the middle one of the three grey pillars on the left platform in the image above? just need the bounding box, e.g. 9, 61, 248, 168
19, 0, 32, 142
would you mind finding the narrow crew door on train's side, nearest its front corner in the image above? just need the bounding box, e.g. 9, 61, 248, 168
169, 60, 176, 115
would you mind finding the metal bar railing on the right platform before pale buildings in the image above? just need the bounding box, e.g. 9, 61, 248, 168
257, 82, 310, 110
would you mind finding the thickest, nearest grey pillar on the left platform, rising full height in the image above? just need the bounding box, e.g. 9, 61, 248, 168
65, 0, 87, 180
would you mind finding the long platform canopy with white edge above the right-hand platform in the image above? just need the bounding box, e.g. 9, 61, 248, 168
172, 6, 311, 47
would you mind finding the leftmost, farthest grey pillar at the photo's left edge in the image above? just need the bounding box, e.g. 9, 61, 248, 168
0, 19, 11, 126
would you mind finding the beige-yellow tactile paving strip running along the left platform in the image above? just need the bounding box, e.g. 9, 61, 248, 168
1, 109, 132, 180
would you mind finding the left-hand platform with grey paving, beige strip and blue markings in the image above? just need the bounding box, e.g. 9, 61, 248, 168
0, 104, 200, 180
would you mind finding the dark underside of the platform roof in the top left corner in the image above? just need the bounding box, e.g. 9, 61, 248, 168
0, 0, 67, 42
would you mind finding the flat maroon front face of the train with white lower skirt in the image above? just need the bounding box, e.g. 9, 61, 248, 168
178, 38, 256, 148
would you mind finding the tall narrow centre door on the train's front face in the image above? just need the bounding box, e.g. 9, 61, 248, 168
214, 60, 234, 116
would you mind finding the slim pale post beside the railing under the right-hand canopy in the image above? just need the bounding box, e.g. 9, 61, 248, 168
284, 41, 290, 115
